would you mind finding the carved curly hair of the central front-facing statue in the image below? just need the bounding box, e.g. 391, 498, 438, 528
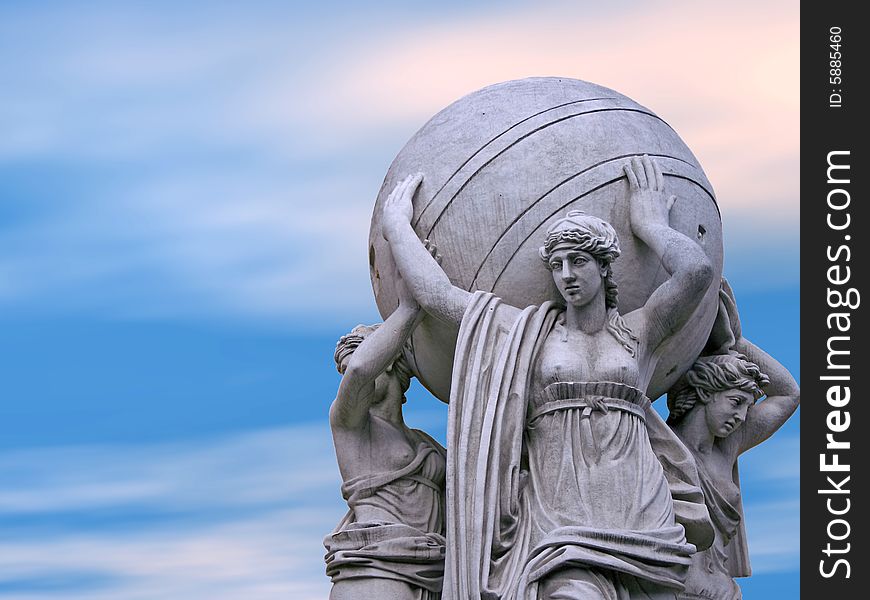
540, 210, 638, 356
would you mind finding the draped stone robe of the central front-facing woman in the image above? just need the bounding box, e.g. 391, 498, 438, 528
443, 292, 710, 600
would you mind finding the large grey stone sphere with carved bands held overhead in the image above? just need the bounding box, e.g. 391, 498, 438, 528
369, 78, 722, 402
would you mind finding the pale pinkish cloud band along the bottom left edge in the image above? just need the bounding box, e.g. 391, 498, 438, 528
0, 509, 334, 600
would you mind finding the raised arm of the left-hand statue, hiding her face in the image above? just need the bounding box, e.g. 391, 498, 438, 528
329, 279, 422, 429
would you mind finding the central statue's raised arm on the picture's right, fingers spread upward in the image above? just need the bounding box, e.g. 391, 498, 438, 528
625, 156, 713, 351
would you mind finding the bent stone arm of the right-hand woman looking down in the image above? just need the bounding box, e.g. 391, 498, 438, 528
734, 337, 801, 452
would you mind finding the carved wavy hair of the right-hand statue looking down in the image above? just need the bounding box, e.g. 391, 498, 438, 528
668, 354, 770, 424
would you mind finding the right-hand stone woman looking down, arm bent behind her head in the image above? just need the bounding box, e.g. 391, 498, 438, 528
668, 288, 800, 600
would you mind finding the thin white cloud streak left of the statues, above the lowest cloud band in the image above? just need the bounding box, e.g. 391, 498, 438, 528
0, 426, 339, 514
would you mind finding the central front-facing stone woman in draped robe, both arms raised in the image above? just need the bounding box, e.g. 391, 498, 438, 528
383, 156, 713, 600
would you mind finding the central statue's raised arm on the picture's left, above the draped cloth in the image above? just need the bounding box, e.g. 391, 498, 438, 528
383, 173, 471, 326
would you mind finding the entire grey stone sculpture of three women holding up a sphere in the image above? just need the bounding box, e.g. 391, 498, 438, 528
324, 78, 799, 600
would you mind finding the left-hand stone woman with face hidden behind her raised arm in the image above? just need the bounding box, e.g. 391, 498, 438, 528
324, 272, 445, 600
